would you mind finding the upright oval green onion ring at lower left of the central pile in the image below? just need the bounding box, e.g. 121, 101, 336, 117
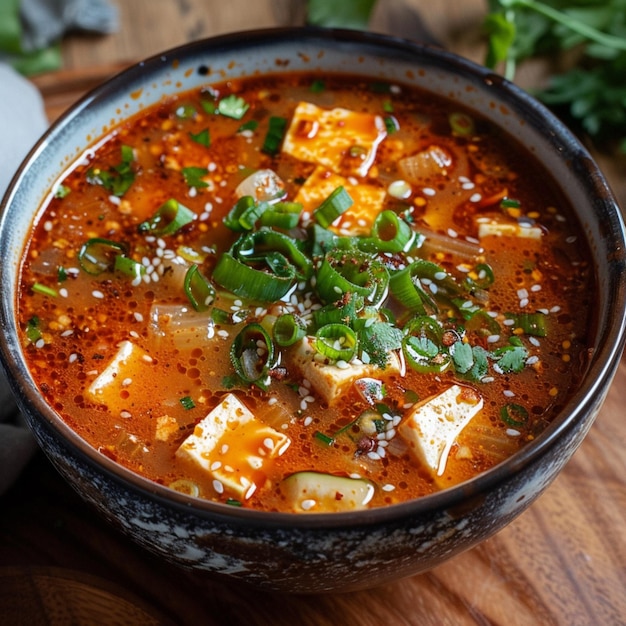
230, 322, 274, 387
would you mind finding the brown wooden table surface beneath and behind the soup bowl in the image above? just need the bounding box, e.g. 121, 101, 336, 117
0, 0, 626, 626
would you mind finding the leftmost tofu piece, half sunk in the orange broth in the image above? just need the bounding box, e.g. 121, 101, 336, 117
86, 341, 152, 413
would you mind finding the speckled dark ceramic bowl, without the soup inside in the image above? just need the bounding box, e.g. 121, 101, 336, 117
0, 29, 626, 593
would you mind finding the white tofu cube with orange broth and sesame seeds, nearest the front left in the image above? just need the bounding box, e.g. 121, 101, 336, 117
176, 393, 291, 500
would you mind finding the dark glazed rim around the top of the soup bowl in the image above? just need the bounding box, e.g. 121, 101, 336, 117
0, 27, 626, 531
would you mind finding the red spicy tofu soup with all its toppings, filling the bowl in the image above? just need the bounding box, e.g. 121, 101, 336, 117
18, 74, 595, 512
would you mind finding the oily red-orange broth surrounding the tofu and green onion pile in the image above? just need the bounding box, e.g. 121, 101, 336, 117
18, 75, 594, 510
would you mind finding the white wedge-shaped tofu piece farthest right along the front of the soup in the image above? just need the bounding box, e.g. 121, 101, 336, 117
397, 385, 483, 476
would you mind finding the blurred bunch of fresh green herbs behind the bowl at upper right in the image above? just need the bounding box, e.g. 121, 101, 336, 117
484, 0, 626, 153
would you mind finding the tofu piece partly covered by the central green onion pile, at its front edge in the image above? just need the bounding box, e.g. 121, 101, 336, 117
293, 337, 400, 406
